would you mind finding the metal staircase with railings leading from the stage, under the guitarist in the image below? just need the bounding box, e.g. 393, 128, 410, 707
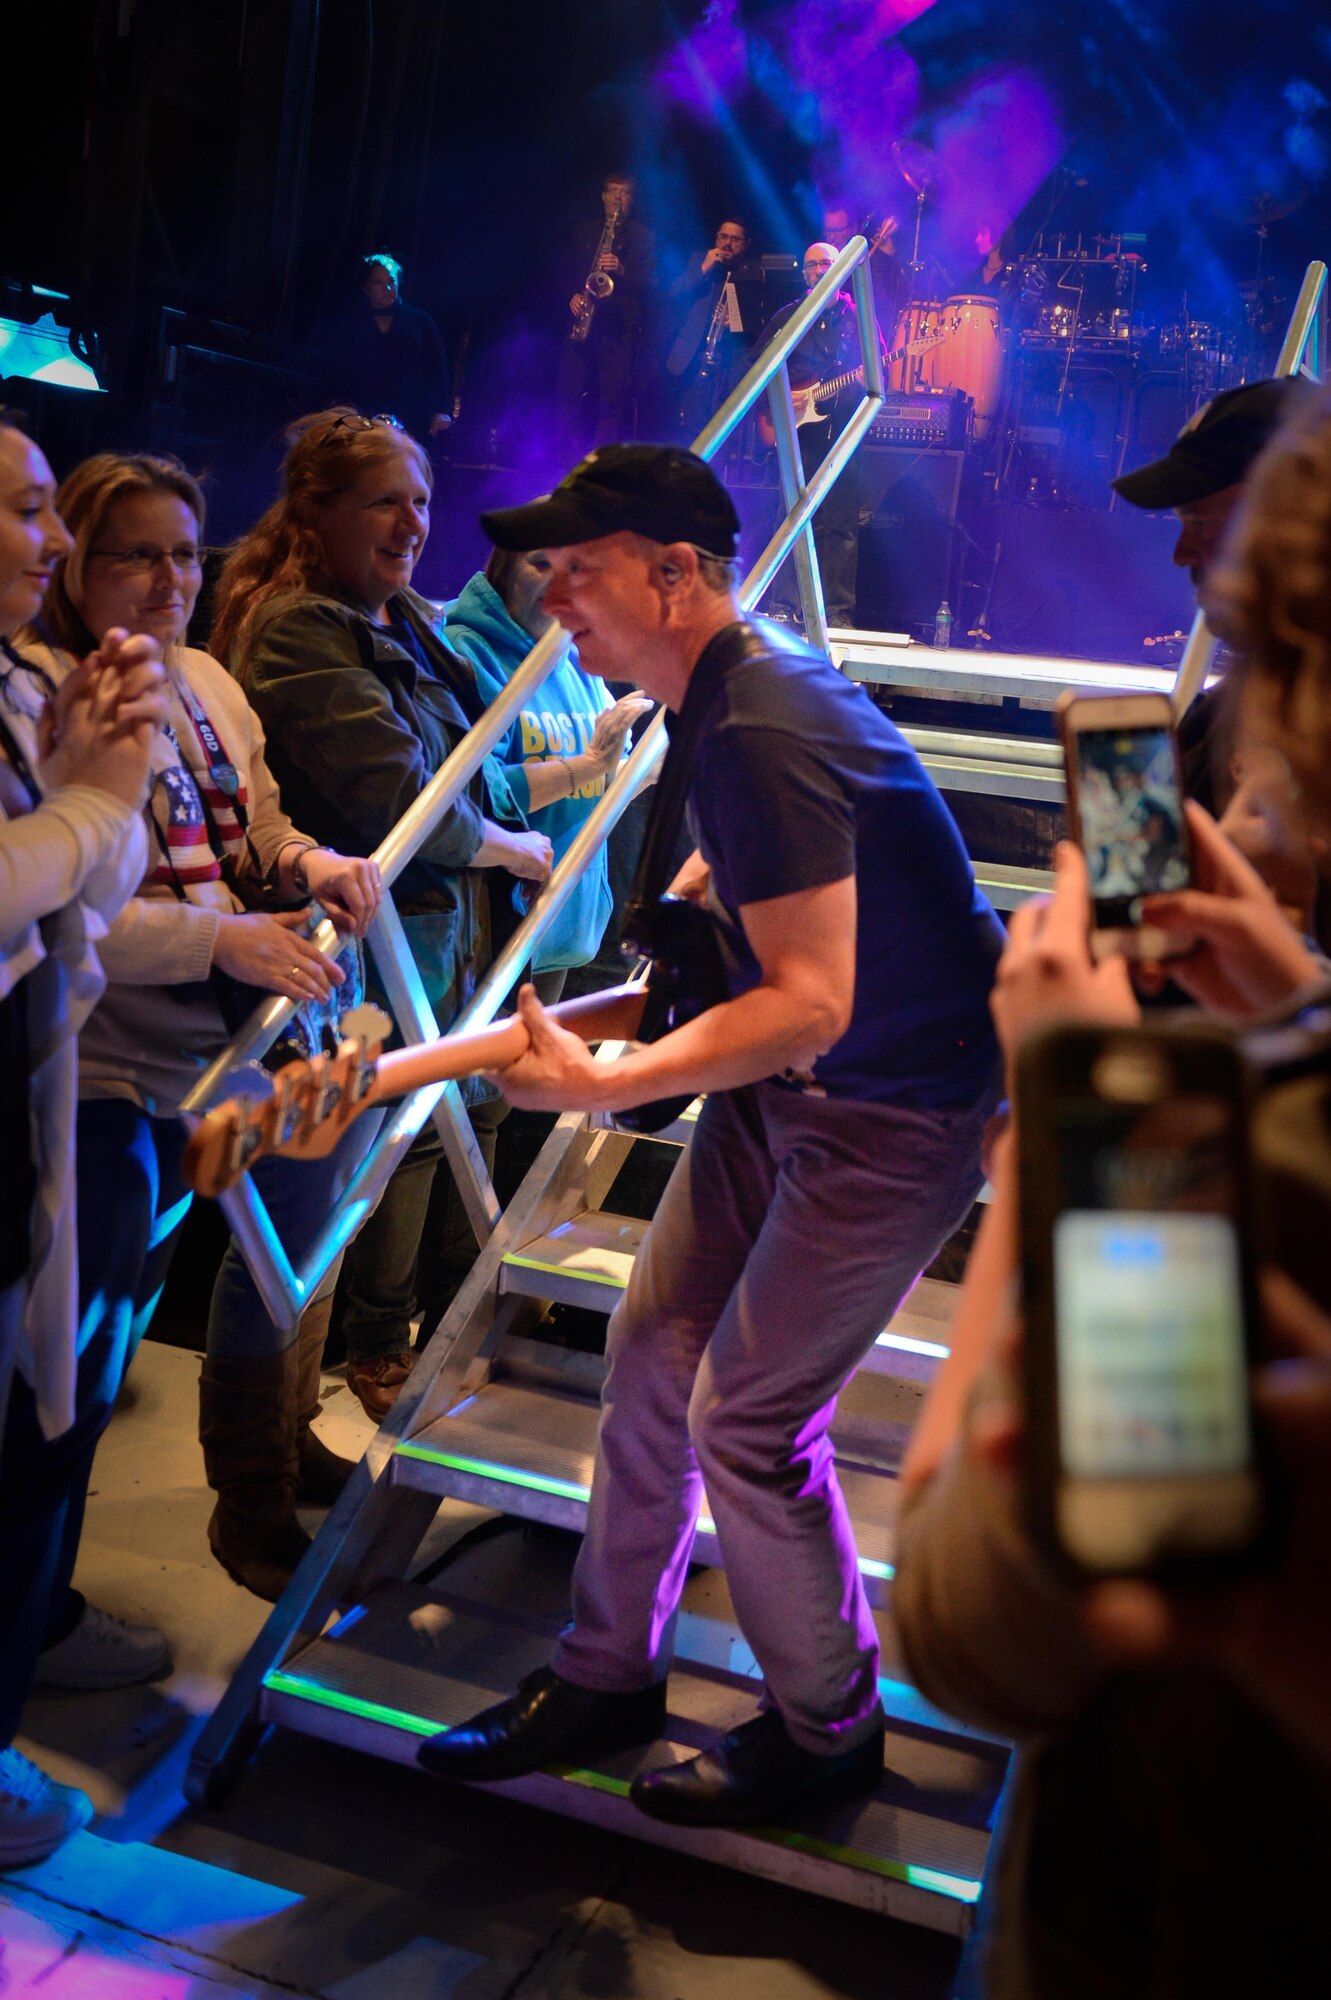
186, 250, 1327, 1932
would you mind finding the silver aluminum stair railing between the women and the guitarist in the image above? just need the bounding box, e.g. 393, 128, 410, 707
180, 236, 883, 1330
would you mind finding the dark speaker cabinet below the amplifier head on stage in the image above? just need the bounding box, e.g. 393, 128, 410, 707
855, 446, 965, 632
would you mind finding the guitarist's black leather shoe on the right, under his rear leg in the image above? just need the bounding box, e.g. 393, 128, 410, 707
630, 1708, 883, 1826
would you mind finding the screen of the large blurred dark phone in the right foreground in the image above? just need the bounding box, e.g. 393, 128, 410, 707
1051, 1090, 1261, 1570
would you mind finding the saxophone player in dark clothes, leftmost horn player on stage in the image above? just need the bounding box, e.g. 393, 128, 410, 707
556, 174, 656, 456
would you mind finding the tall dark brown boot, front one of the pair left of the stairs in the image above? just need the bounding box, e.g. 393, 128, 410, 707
198, 1340, 310, 1604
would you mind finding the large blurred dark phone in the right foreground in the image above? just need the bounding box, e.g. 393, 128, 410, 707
1015, 1024, 1267, 1576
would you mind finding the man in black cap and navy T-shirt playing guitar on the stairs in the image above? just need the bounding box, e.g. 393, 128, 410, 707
422, 446, 1001, 1824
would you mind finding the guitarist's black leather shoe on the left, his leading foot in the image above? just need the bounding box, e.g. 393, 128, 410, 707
418, 1666, 666, 1782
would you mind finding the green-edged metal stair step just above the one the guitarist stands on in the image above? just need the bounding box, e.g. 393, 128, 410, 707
392, 1380, 899, 1606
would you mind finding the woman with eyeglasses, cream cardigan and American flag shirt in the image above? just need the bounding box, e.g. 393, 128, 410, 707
28, 452, 380, 1608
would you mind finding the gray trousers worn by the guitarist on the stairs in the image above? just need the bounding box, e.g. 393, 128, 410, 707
554, 1084, 997, 1752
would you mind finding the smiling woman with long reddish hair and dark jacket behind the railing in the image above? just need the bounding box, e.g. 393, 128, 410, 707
212, 410, 552, 1422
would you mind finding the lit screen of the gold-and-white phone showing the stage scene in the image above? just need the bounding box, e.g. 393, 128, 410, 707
1069, 724, 1189, 930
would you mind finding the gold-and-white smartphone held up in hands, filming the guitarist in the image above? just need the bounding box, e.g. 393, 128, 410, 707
1057, 694, 1193, 960
